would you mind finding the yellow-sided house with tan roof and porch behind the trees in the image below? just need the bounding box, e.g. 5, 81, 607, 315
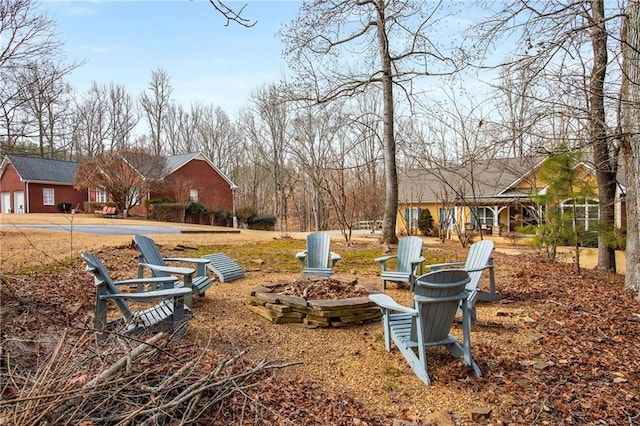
396, 156, 625, 238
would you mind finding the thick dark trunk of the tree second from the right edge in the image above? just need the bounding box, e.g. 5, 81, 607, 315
589, 0, 616, 271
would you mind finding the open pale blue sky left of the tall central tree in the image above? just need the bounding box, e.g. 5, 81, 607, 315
40, 0, 301, 116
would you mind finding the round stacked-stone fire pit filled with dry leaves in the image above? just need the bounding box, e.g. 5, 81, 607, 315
249, 277, 381, 327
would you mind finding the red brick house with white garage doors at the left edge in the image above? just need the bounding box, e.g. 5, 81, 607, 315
0, 155, 88, 213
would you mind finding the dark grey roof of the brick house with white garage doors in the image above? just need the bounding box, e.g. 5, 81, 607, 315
0, 154, 79, 185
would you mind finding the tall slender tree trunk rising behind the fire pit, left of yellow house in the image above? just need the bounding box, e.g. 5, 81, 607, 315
376, 0, 398, 244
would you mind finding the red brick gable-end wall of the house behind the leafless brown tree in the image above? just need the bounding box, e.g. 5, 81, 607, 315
151, 160, 233, 211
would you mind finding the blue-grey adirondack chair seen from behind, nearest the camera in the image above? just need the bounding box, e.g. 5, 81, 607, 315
369, 269, 482, 385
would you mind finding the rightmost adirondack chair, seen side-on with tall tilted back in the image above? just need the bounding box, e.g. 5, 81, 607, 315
425, 240, 500, 321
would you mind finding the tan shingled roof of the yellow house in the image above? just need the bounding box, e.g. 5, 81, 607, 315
398, 157, 544, 203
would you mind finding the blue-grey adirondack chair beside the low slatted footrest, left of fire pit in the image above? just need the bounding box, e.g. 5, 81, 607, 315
133, 235, 212, 306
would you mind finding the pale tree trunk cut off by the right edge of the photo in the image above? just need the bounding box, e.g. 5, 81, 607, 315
622, 0, 640, 301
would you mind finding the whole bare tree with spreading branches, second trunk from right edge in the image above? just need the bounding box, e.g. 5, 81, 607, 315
476, 0, 620, 270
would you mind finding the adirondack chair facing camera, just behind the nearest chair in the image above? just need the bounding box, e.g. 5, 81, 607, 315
374, 237, 425, 291
